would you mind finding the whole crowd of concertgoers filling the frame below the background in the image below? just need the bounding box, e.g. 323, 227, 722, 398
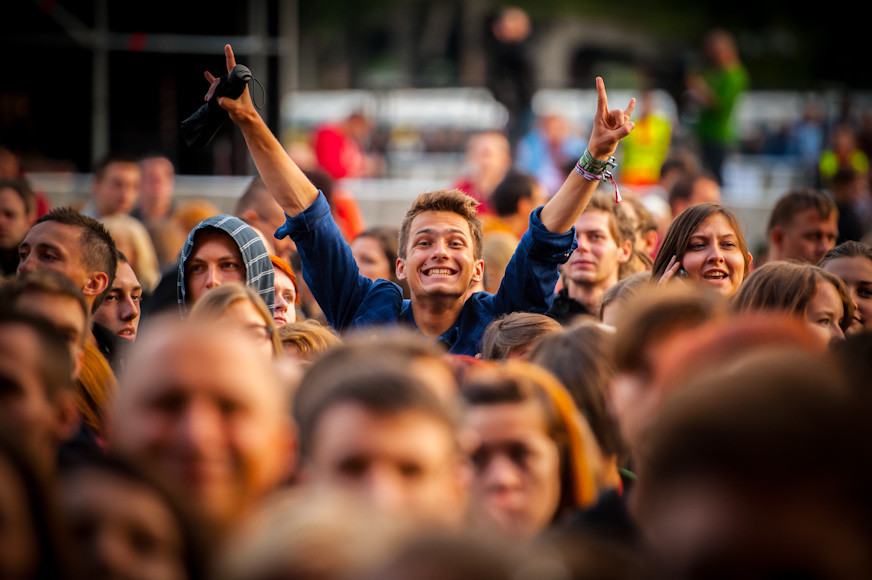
0, 35, 872, 580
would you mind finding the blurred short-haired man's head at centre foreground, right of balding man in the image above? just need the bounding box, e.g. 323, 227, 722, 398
293, 333, 468, 528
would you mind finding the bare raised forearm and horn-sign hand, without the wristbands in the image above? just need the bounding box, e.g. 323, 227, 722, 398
539, 77, 636, 233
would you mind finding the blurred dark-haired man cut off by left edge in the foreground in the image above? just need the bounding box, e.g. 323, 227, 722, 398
0, 308, 79, 470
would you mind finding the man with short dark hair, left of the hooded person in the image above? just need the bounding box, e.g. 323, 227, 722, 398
18, 207, 121, 369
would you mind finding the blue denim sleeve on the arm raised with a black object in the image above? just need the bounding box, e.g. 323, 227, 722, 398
275, 194, 402, 330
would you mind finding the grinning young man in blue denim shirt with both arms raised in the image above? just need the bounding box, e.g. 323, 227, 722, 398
206, 45, 635, 355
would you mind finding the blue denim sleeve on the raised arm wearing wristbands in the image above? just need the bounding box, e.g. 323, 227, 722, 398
493, 208, 578, 316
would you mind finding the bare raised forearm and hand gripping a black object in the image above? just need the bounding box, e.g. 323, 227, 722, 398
205, 44, 318, 217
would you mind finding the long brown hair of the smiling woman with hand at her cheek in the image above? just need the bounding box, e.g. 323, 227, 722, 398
651, 203, 751, 282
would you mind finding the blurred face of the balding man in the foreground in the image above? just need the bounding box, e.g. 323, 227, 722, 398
111, 324, 293, 530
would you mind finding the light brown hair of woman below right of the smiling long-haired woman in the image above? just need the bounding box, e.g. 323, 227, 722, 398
732, 260, 854, 331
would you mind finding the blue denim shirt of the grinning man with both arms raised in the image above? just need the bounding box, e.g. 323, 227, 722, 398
275, 194, 577, 356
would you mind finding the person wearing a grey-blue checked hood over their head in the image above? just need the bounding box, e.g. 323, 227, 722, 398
176, 214, 275, 317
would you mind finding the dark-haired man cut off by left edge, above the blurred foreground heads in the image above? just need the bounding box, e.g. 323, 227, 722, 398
0, 179, 36, 276
